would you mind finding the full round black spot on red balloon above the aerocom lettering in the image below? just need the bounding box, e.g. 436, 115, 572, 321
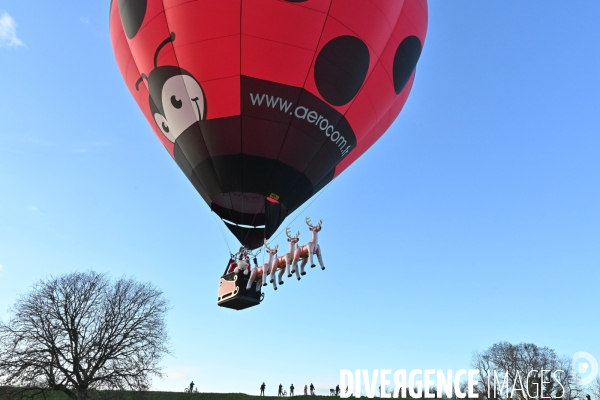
315, 36, 370, 106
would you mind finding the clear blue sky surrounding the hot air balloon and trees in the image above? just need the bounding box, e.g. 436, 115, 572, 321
0, 0, 600, 394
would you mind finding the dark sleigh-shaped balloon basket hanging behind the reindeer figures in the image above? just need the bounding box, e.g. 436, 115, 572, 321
217, 272, 264, 311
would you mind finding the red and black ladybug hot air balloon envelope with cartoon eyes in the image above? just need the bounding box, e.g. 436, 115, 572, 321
110, 0, 427, 248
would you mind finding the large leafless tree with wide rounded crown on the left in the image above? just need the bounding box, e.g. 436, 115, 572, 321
0, 272, 168, 400
